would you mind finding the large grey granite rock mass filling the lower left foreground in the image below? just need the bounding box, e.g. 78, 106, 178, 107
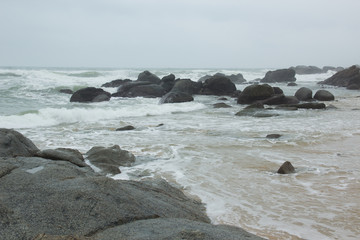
0, 129, 261, 240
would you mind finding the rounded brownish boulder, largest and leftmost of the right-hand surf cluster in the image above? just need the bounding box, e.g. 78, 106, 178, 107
237, 84, 275, 104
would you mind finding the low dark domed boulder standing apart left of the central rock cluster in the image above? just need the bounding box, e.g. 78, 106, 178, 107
70, 87, 111, 102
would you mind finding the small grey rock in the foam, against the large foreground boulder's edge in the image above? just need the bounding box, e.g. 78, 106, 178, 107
86, 145, 135, 174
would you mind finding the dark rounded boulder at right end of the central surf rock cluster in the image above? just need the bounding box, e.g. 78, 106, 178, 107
200, 76, 236, 96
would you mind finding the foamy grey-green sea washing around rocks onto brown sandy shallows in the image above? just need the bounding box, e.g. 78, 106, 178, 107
0, 67, 360, 239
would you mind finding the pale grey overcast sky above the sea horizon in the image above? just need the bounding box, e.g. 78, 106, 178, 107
0, 0, 360, 68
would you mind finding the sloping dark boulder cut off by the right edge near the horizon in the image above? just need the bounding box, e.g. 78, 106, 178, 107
319, 65, 360, 89
